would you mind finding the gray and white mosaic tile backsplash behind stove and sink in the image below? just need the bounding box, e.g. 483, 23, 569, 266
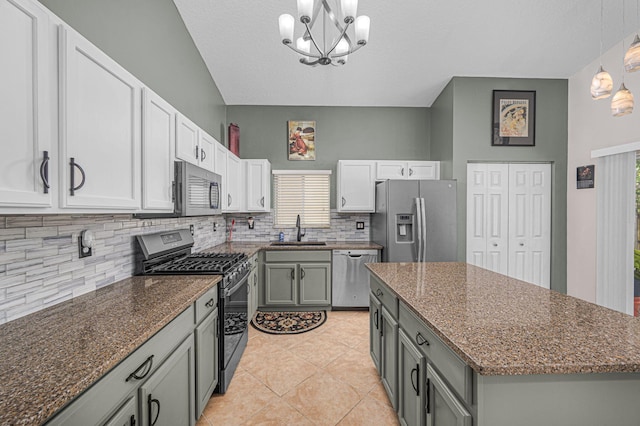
0, 212, 369, 324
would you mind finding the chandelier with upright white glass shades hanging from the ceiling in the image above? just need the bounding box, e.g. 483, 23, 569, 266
278, 0, 371, 66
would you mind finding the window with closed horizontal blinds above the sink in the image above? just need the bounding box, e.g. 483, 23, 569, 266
273, 170, 331, 228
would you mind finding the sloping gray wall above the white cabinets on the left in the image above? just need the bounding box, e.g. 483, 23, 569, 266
40, 0, 227, 142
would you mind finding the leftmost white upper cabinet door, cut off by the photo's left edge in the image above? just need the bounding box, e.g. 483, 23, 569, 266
0, 0, 52, 207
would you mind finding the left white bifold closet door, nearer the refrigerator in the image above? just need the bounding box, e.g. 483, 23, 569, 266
467, 163, 509, 274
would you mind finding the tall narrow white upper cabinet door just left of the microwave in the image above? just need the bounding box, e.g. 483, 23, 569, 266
142, 88, 177, 212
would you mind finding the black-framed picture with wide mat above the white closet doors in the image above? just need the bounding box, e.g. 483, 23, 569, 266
491, 90, 536, 146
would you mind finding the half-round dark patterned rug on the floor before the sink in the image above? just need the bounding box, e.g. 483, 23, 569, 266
251, 311, 327, 334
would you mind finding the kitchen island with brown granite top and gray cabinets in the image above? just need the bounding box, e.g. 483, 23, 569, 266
368, 263, 640, 426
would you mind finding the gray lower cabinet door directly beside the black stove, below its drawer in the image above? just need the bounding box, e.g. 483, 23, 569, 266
195, 309, 219, 419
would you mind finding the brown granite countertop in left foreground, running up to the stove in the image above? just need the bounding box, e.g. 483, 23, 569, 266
0, 275, 220, 425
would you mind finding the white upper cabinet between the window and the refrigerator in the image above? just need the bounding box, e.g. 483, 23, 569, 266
336, 160, 376, 212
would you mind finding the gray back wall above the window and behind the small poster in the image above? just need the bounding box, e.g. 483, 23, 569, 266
227, 106, 430, 208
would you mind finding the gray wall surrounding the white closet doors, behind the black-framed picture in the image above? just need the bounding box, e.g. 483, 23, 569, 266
432, 77, 568, 293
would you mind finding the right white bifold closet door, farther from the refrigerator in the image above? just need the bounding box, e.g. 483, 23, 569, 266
508, 164, 551, 288
